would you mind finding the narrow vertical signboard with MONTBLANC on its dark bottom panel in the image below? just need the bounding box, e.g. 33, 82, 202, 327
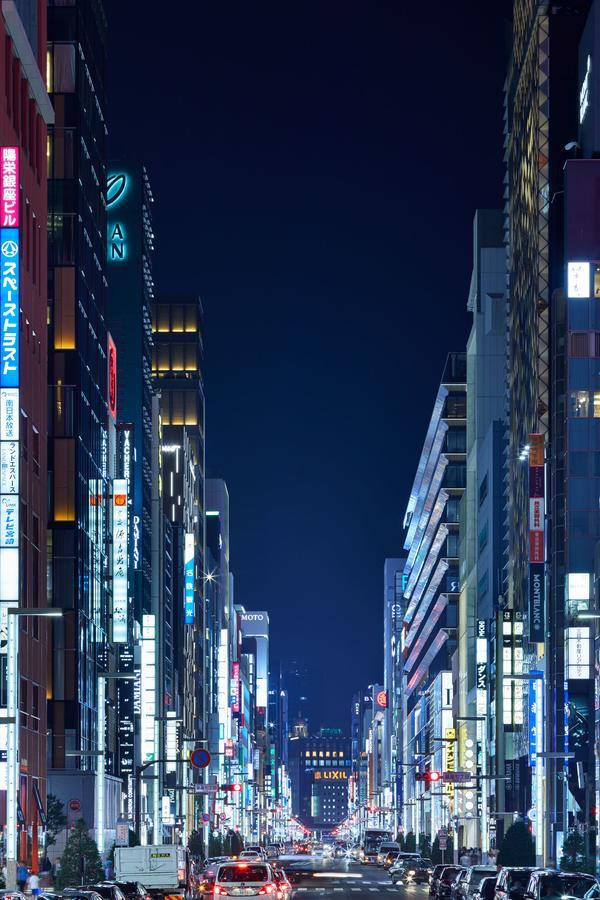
529, 434, 546, 643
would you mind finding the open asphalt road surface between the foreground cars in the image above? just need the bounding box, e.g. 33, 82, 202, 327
280, 856, 429, 900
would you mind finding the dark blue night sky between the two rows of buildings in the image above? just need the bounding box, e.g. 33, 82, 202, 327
107, 0, 509, 729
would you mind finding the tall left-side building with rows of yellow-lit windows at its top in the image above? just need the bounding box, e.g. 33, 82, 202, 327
149, 295, 209, 834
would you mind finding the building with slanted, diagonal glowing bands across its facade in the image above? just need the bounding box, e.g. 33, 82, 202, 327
402, 353, 468, 839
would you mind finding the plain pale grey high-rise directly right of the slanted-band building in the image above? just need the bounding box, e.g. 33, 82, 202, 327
462, 210, 504, 852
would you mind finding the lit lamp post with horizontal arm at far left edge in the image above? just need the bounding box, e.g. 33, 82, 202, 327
2, 606, 63, 890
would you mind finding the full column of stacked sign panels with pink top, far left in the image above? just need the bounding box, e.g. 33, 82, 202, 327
0, 147, 20, 861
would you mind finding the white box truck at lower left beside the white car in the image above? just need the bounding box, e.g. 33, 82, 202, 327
115, 844, 193, 900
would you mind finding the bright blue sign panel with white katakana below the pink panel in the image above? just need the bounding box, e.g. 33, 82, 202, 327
0, 228, 19, 387
